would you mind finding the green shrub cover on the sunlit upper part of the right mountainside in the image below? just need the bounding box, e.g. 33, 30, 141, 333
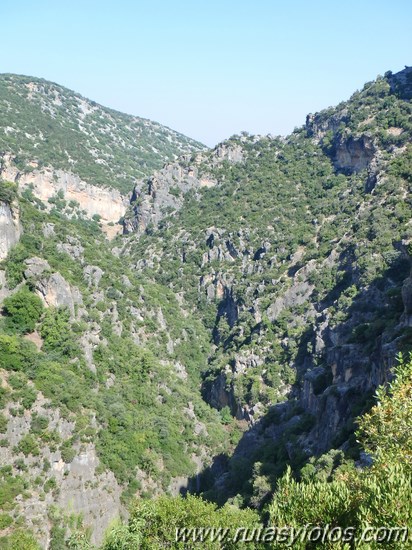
125, 74, 412, 418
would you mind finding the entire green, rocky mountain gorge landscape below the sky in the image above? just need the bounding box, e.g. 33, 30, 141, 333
0, 69, 412, 550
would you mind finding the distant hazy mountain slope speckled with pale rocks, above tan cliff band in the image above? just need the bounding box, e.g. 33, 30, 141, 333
0, 74, 204, 192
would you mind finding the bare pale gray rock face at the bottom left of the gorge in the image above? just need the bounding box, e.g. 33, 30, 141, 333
0, 390, 122, 548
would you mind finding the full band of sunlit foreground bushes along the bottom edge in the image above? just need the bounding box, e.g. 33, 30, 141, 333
76, 357, 412, 550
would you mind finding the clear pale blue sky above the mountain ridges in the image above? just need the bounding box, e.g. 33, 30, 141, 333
0, 0, 412, 146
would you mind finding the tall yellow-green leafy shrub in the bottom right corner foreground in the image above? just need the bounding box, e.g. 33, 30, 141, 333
269, 356, 412, 549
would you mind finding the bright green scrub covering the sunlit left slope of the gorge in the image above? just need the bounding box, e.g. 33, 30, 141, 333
0, 195, 227, 547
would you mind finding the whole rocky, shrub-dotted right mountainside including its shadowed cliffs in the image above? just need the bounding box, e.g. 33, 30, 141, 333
124, 71, 412, 504
